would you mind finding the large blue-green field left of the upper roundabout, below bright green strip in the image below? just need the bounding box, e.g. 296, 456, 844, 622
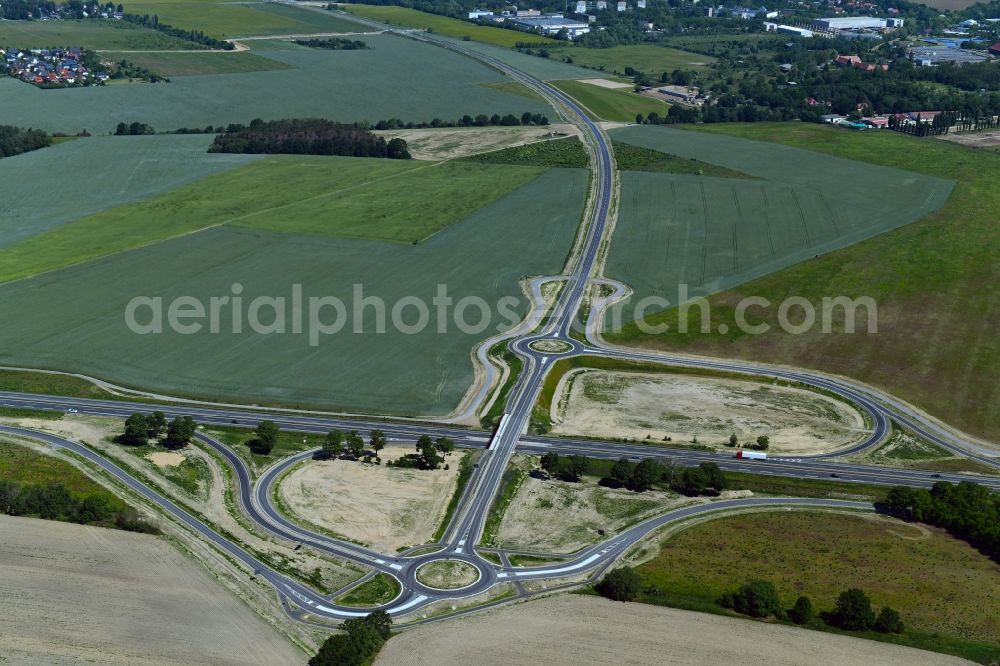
0, 164, 587, 414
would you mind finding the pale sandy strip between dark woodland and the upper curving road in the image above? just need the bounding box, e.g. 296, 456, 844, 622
375, 124, 579, 160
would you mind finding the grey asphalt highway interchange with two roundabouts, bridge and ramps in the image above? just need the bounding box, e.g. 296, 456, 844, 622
0, 7, 1000, 621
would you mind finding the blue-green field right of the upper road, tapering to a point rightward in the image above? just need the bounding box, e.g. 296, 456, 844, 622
606, 126, 951, 322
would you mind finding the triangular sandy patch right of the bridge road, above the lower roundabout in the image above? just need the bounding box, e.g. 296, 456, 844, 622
496, 476, 699, 553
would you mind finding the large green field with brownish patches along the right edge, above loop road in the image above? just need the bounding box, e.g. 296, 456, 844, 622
612, 123, 1000, 440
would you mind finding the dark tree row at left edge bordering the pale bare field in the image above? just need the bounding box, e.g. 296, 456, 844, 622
0, 480, 160, 534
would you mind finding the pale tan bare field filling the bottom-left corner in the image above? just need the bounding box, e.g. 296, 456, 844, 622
0, 516, 305, 665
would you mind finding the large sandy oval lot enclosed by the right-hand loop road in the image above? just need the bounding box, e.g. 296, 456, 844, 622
552, 370, 866, 454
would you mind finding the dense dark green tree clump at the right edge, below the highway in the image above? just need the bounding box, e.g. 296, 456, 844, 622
885, 481, 1000, 561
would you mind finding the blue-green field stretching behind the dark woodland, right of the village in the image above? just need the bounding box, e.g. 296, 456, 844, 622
0, 35, 553, 134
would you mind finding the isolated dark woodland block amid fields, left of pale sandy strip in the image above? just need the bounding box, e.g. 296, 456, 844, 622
208, 118, 410, 159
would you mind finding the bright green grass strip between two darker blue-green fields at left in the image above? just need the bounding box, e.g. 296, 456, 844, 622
0, 157, 543, 282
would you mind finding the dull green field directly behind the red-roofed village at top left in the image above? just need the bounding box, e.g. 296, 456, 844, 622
0, 19, 205, 50
